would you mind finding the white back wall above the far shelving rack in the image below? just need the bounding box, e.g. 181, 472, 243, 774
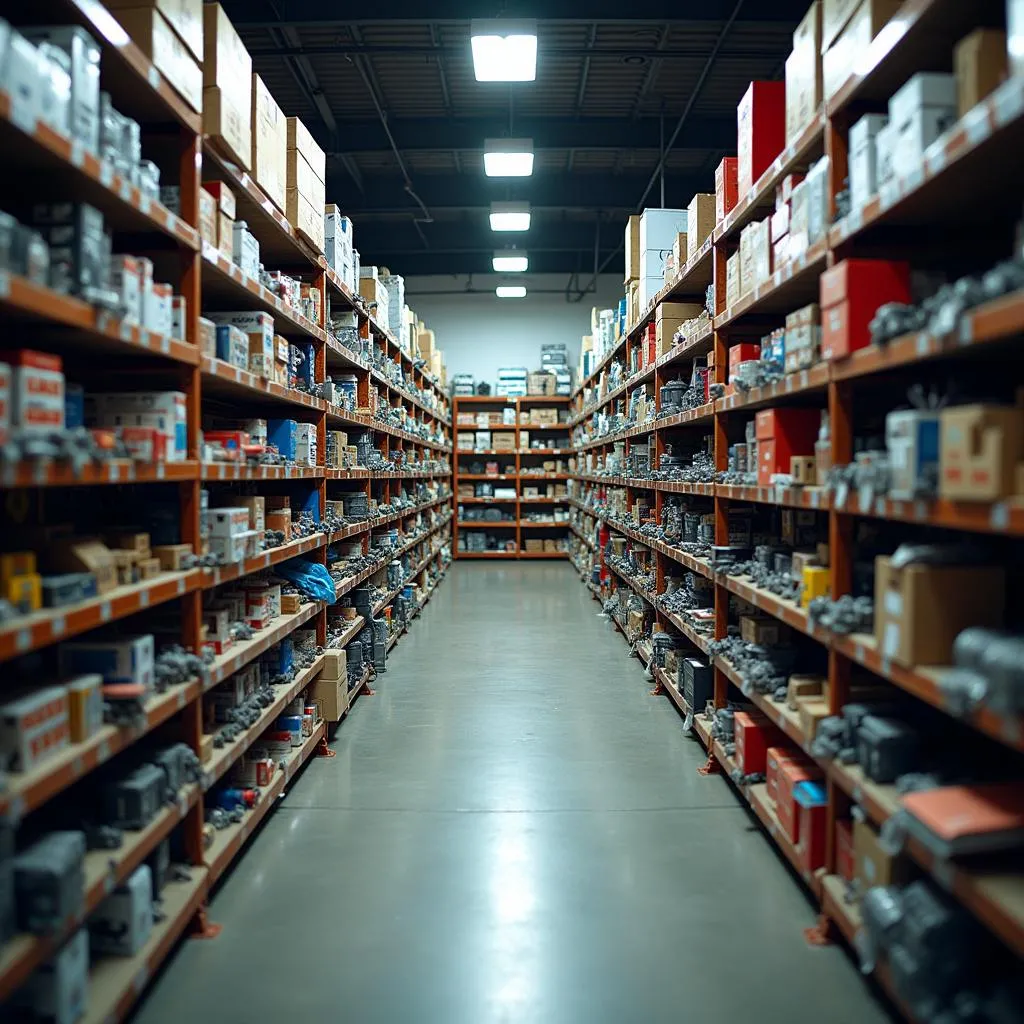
406, 274, 624, 387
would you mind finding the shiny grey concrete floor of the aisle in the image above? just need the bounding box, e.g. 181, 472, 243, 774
137, 562, 889, 1024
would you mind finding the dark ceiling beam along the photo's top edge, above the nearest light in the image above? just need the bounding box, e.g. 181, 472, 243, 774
225, 0, 807, 28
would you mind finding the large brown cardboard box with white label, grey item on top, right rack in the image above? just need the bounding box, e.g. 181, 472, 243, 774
874, 555, 1006, 668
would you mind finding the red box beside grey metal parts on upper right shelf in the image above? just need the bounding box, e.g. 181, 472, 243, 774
820, 259, 910, 359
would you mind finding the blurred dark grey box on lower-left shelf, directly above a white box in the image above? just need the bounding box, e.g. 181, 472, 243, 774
14, 831, 85, 935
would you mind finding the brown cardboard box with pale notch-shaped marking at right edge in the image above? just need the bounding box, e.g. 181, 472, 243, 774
939, 404, 1024, 502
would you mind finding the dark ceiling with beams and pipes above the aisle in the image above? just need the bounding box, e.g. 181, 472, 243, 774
225, 0, 808, 285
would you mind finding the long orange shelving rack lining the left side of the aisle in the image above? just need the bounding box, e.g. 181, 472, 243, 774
0, 0, 452, 1021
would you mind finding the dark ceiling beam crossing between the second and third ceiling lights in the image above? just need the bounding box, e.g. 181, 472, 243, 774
328, 173, 715, 218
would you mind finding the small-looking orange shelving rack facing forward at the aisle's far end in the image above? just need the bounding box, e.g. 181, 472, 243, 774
453, 395, 571, 559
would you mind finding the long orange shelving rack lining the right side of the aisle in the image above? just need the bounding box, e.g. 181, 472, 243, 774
570, 0, 1024, 1017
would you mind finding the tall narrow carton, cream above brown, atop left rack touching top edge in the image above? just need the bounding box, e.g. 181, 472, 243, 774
203, 3, 253, 171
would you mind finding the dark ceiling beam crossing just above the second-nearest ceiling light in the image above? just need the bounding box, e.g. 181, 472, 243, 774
319, 115, 736, 154
